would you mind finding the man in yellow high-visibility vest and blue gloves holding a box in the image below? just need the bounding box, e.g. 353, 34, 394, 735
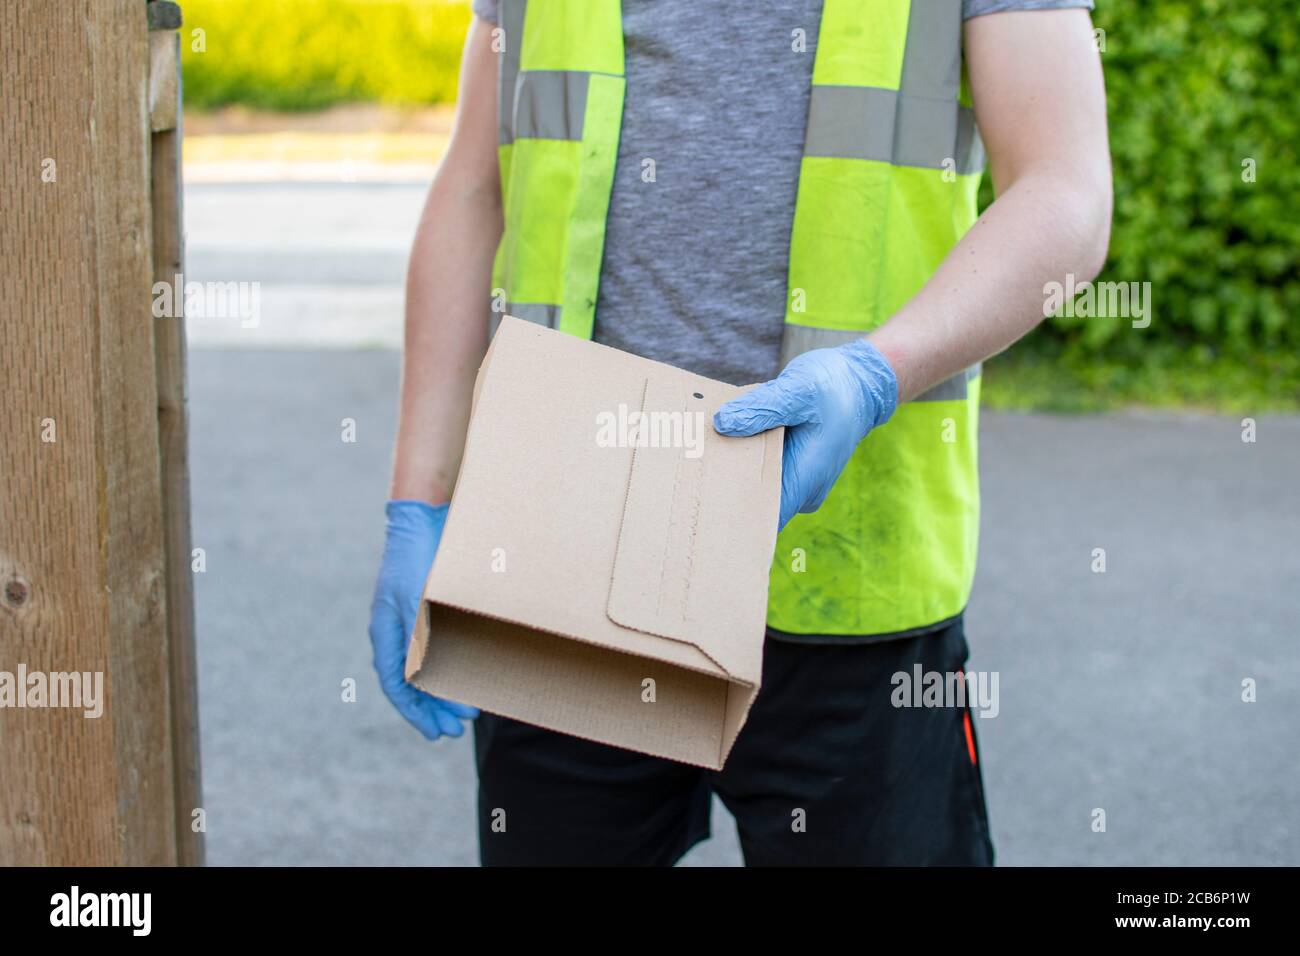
371, 0, 1112, 865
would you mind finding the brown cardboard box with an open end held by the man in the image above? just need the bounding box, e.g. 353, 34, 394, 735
406, 316, 783, 769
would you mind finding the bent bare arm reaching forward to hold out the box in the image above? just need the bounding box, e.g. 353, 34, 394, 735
867, 9, 1112, 402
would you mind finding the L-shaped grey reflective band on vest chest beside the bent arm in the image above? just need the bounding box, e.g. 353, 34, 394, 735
803, 0, 984, 174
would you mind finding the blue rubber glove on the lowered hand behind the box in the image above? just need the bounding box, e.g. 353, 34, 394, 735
371, 501, 478, 740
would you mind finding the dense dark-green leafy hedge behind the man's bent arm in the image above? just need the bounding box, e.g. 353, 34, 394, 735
985, 0, 1300, 374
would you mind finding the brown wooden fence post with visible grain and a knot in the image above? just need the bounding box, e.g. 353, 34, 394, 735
0, 0, 202, 865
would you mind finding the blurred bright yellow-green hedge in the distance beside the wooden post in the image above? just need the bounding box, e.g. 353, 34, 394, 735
181, 0, 469, 109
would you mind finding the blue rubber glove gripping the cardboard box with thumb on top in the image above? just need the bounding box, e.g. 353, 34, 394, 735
714, 338, 898, 528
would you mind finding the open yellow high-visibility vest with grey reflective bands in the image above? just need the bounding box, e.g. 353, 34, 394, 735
493, 0, 984, 635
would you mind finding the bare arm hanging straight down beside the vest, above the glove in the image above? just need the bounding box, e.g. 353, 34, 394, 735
390, 18, 502, 505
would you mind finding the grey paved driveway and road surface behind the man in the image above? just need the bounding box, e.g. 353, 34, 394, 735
186, 185, 1300, 865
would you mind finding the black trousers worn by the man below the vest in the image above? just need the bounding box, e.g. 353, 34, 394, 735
475, 623, 993, 865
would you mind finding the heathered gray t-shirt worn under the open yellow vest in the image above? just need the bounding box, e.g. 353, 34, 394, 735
473, 0, 1092, 385
